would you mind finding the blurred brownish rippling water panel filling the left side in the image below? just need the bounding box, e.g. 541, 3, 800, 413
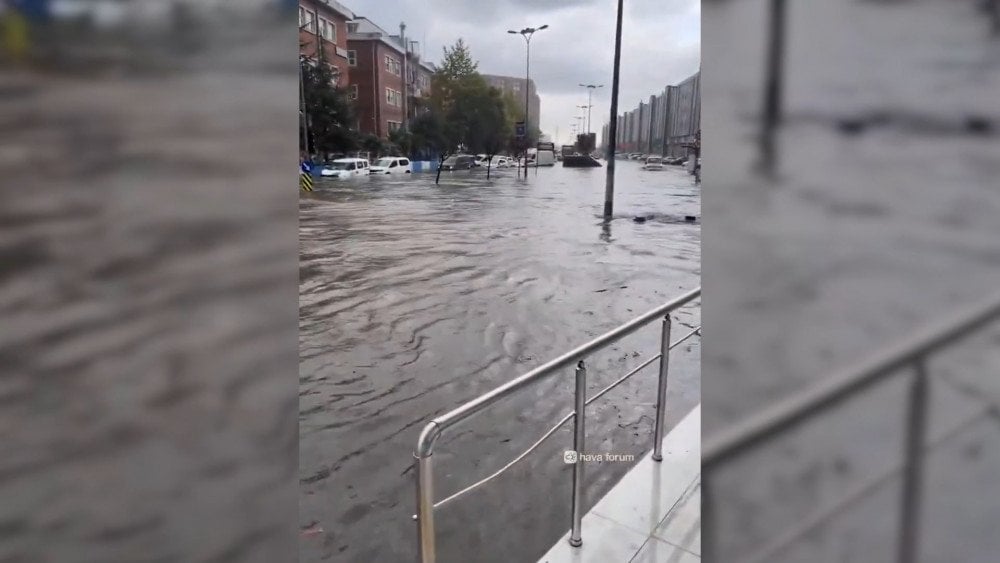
0, 0, 298, 562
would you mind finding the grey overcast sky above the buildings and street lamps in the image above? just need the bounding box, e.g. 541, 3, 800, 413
348, 0, 701, 148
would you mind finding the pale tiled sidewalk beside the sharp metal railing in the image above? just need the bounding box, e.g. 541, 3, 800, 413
539, 405, 701, 563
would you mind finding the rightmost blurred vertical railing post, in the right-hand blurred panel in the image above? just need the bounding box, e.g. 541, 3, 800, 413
898, 358, 927, 563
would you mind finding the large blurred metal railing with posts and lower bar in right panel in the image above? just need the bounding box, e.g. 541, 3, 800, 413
702, 294, 1000, 563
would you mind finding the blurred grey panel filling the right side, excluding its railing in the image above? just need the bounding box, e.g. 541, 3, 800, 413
702, 0, 1000, 562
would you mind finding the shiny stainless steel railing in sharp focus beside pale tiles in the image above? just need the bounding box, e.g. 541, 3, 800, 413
413, 287, 701, 563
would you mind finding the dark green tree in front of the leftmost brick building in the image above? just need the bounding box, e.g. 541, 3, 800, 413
299, 55, 358, 153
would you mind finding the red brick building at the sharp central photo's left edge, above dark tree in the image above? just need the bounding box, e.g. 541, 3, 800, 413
299, 0, 354, 88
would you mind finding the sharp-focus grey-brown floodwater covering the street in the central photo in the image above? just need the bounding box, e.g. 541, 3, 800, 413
299, 161, 701, 562
